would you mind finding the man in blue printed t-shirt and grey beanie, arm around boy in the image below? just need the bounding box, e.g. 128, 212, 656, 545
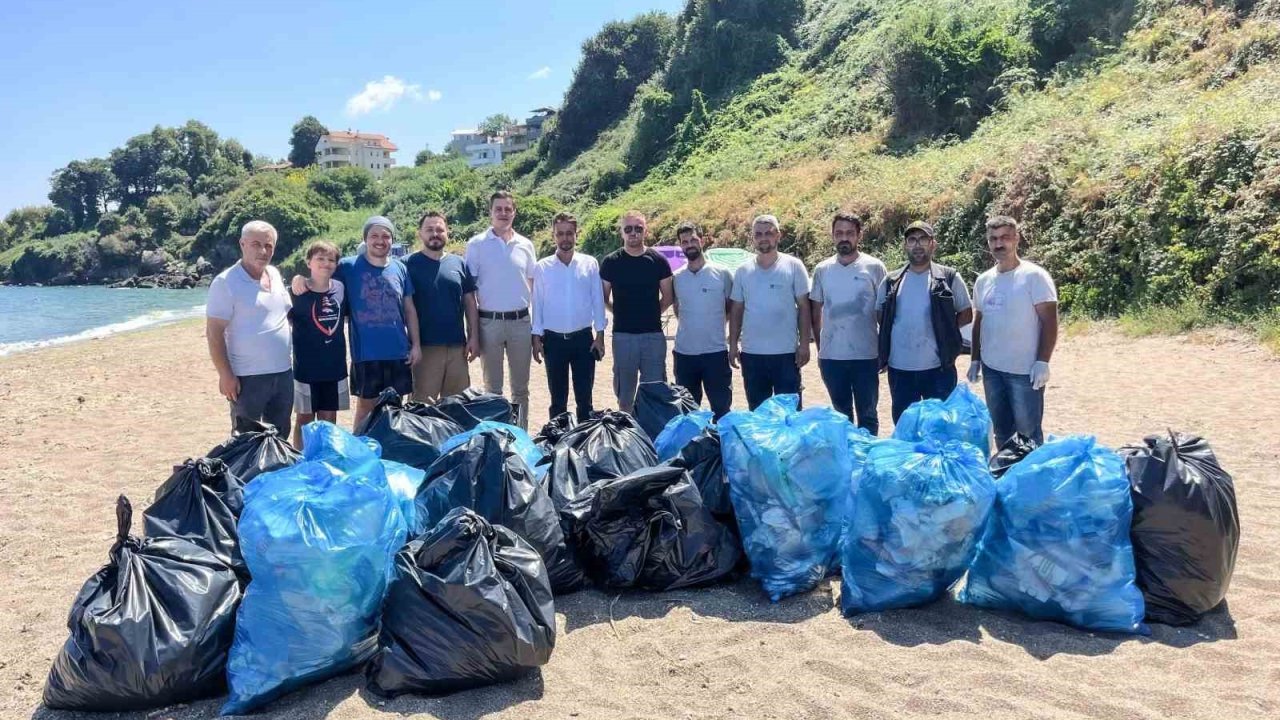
293, 215, 422, 428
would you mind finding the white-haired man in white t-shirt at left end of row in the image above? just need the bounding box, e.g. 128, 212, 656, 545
205, 220, 293, 437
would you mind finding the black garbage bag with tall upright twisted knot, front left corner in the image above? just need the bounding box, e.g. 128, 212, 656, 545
45, 496, 241, 712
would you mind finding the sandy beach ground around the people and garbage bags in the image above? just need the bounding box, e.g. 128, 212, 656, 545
0, 323, 1280, 719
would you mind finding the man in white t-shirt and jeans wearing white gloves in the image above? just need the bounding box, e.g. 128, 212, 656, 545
969, 215, 1057, 447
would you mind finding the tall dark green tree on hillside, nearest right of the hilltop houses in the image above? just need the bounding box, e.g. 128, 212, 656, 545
543, 13, 676, 165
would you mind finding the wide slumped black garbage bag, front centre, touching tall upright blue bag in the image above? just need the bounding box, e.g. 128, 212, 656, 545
564, 465, 741, 591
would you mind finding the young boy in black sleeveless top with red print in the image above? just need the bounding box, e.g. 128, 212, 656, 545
289, 241, 351, 450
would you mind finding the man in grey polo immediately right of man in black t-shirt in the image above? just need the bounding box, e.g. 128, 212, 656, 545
671, 223, 733, 420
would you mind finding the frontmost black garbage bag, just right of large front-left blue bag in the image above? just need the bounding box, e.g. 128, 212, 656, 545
365, 507, 556, 697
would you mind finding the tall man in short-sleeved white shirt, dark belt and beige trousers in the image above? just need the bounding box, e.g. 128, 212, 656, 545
466, 190, 538, 429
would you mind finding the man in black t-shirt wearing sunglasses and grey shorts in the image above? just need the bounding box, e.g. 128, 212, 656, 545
600, 210, 673, 413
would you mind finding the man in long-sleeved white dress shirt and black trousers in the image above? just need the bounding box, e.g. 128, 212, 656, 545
532, 213, 605, 420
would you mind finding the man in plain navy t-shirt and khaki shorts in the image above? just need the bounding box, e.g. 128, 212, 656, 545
404, 210, 480, 402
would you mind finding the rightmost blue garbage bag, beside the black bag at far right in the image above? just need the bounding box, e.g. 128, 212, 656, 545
959, 436, 1148, 634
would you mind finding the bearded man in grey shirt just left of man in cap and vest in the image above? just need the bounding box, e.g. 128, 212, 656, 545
809, 207, 887, 436
